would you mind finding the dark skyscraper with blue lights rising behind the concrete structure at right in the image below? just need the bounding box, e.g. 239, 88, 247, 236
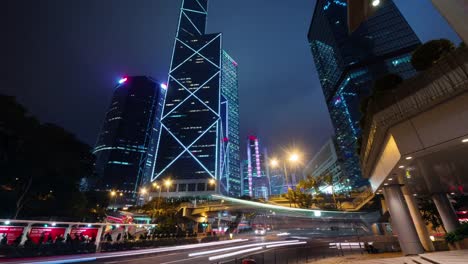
308, 0, 420, 187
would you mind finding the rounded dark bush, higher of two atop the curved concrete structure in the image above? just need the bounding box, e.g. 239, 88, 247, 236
411, 39, 455, 71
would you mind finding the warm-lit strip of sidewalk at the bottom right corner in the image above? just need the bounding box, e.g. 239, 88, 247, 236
308, 250, 468, 264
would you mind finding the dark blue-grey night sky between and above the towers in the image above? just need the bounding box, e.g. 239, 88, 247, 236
0, 0, 460, 157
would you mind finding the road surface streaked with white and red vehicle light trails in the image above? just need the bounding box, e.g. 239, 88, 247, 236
2, 230, 362, 264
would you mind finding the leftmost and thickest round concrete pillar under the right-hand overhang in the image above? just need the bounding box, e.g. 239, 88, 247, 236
384, 185, 424, 255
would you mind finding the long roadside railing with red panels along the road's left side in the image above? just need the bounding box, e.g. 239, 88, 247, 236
0, 219, 215, 257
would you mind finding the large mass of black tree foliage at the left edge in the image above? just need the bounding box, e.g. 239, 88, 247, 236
0, 95, 94, 217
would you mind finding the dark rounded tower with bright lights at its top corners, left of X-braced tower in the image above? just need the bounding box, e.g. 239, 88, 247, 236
94, 76, 166, 202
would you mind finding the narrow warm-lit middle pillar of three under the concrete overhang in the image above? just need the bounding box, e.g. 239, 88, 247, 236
402, 186, 435, 252
